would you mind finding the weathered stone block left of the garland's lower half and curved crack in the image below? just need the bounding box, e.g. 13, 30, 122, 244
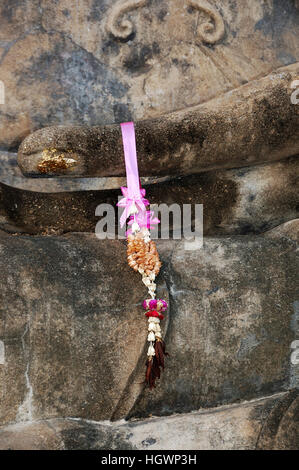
0, 234, 167, 424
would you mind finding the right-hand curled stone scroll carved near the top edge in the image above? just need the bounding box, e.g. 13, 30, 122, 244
188, 0, 225, 44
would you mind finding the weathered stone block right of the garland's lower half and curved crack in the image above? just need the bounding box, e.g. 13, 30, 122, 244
129, 231, 299, 417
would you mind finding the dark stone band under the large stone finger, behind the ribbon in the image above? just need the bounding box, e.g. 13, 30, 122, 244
0, 157, 299, 235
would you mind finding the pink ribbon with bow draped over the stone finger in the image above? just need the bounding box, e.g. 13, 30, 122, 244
117, 122, 149, 227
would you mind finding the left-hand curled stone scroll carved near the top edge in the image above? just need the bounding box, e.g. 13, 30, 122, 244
106, 0, 147, 39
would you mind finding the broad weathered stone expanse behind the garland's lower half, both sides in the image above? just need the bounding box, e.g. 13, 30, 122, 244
0, 226, 298, 424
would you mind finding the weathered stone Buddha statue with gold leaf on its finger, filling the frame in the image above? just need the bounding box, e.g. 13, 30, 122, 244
0, 0, 299, 449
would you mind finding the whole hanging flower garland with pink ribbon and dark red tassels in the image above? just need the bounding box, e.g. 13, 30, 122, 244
117, 122, 168, 388
